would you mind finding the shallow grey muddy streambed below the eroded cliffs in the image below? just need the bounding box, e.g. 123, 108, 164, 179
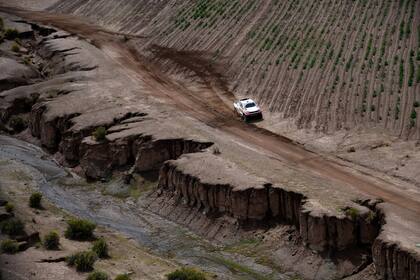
0, 135, 289, 279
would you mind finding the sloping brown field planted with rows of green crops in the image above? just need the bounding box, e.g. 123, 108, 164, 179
51, 0, 420, 138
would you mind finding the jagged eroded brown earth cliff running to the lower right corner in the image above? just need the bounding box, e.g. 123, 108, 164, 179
155, 153, 420, 280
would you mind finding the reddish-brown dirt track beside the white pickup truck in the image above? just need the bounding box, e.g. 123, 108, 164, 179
0, 6, 420, 217
